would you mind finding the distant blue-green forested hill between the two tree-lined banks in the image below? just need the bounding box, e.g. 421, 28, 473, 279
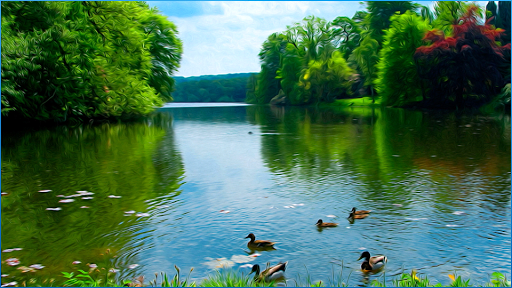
172, 73, 257, 102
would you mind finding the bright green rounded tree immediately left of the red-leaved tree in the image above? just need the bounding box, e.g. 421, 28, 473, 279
375, 11, 432, 106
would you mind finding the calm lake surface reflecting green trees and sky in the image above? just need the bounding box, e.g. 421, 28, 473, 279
1, 104, 511, 286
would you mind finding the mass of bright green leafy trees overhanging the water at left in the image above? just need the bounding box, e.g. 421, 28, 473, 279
2, 1, 182, 121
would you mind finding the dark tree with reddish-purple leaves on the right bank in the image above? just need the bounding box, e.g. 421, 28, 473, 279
414, 5, 510, 108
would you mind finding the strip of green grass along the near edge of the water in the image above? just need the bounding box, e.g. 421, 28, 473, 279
6, 266, 511, 287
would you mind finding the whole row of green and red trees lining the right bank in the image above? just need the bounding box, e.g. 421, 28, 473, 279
246, 1, 511, 109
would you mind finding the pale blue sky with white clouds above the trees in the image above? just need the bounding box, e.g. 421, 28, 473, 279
147, 1, 484, 77
